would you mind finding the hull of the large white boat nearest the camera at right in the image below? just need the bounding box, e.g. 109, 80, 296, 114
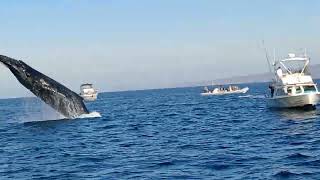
267, 93, 320, 108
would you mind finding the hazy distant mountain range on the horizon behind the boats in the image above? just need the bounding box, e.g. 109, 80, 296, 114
193, 64, 320, 86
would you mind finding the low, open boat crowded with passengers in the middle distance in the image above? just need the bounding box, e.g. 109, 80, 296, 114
201, 86, 249, 96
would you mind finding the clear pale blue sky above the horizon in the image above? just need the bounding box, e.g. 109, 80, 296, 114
0, 0, 320, 98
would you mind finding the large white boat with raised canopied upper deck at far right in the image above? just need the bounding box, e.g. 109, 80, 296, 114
267, 53, 320, 109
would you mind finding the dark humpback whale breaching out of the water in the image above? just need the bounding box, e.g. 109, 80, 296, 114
0, 55, 89, 118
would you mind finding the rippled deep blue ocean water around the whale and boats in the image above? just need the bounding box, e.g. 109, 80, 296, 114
0, 83, 320, 179
